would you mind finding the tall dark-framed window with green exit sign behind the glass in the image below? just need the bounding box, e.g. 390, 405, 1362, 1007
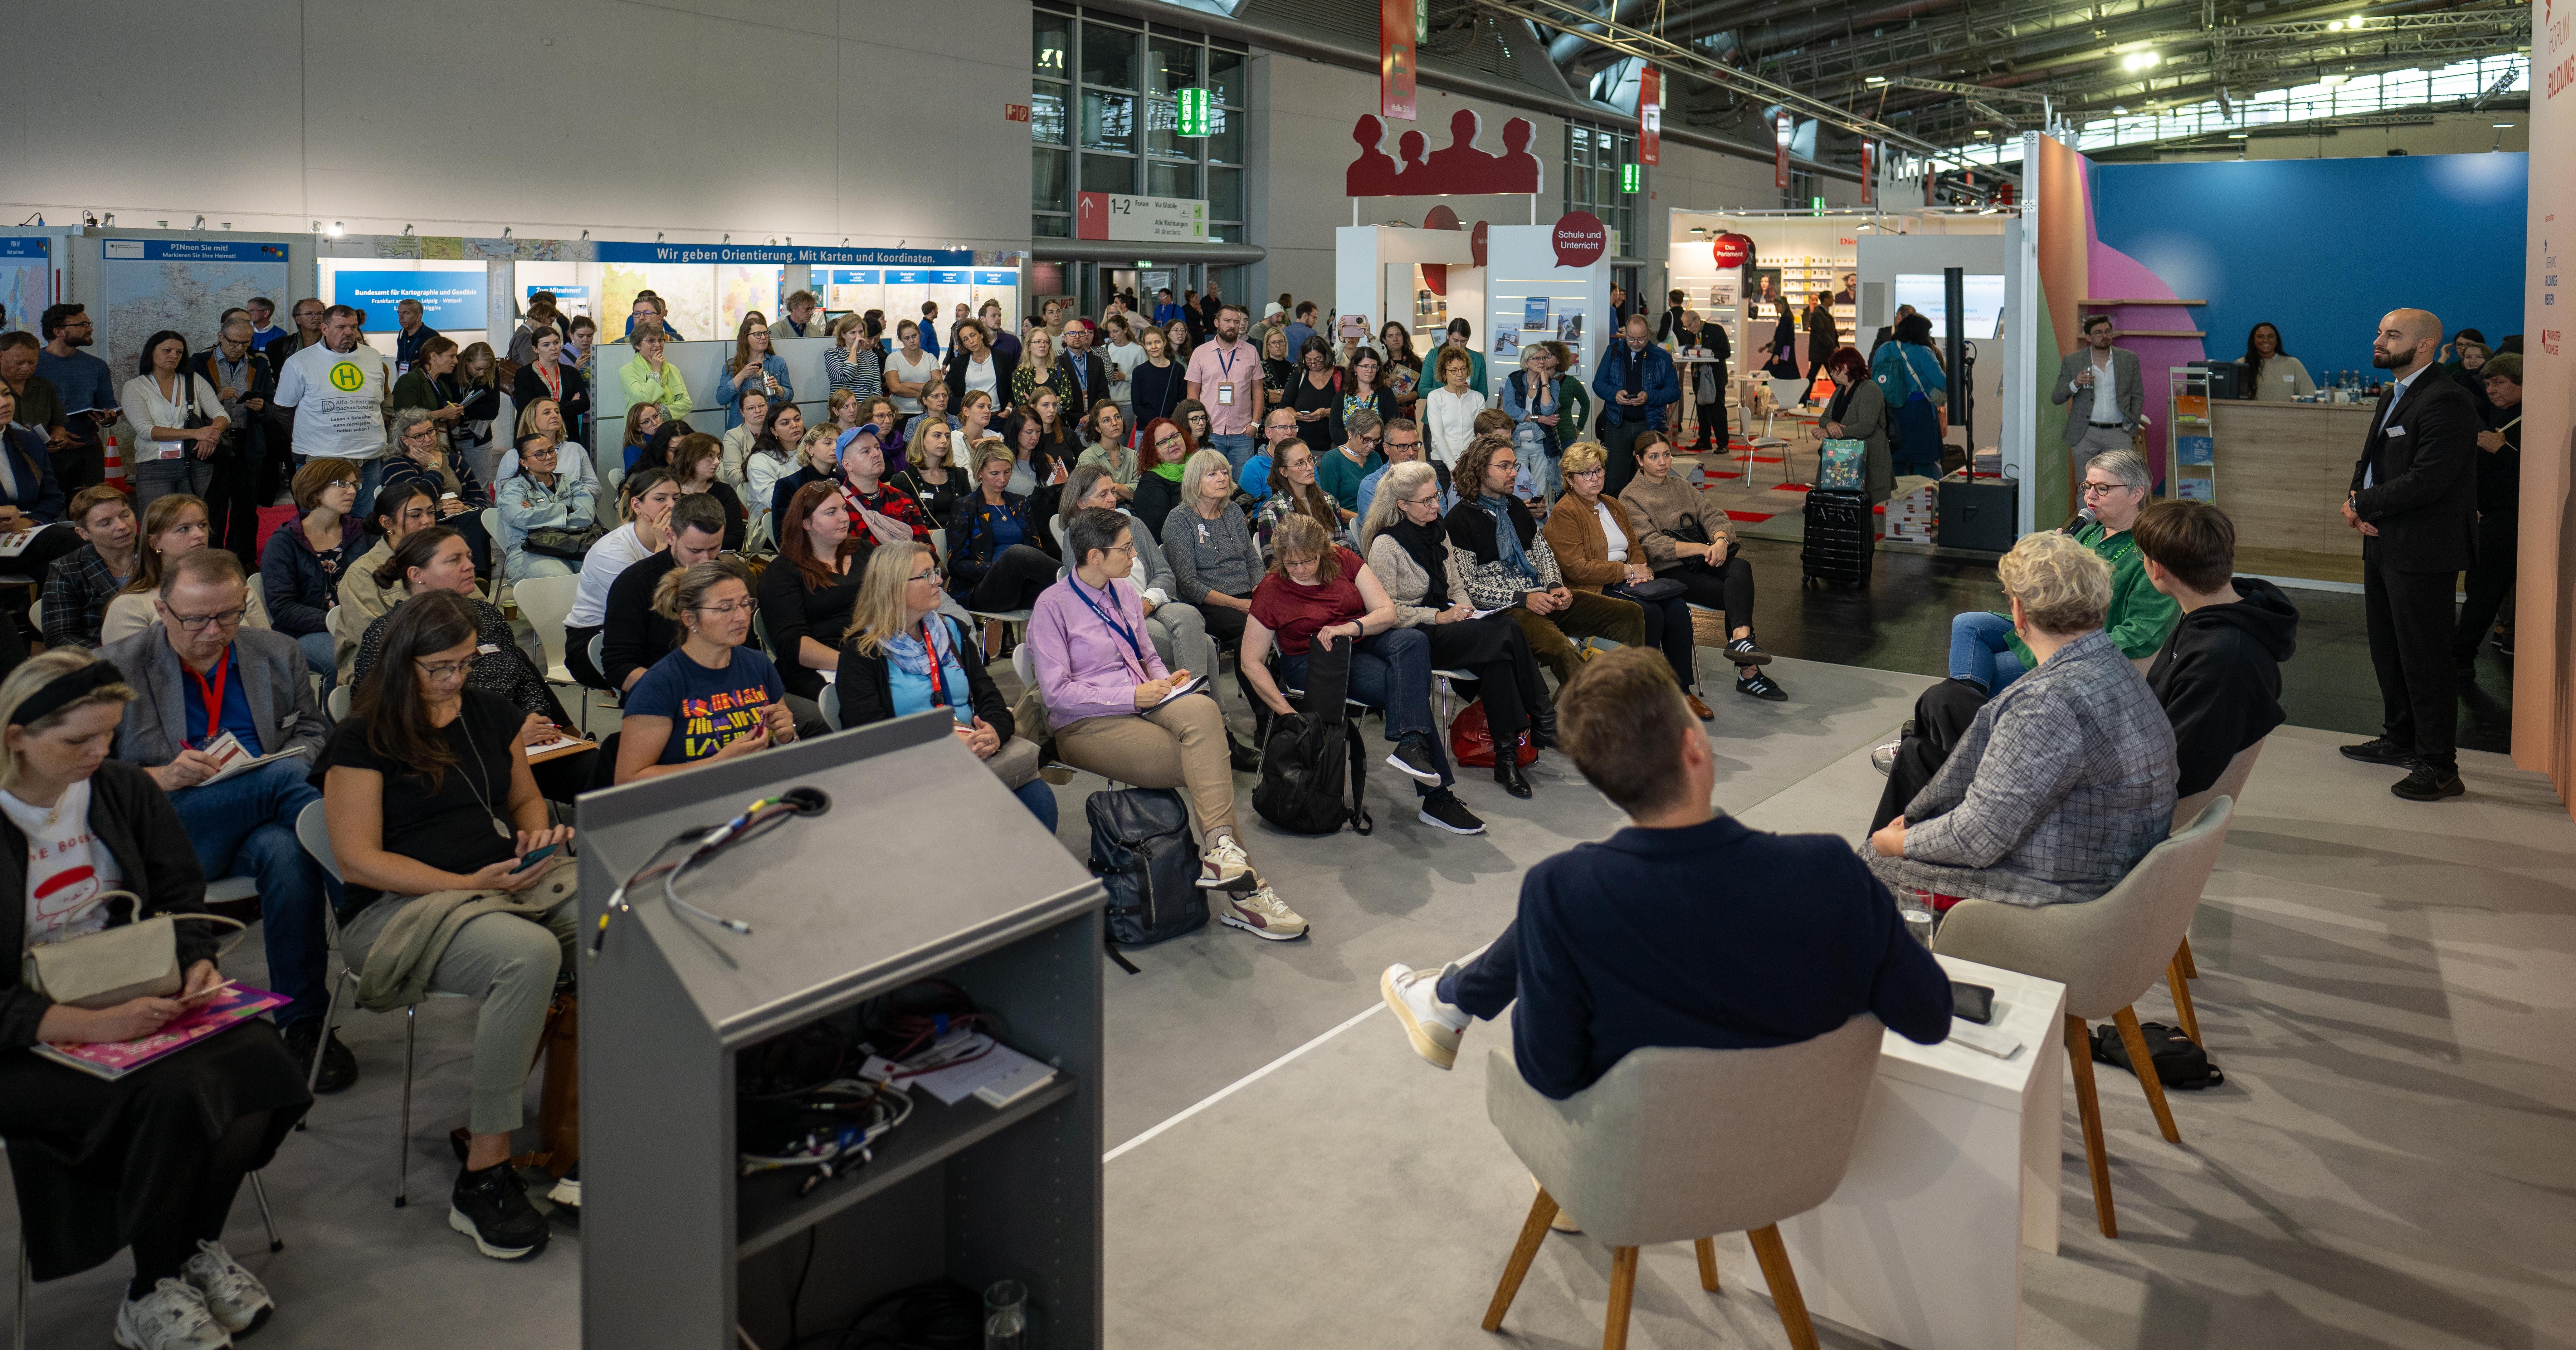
1028, 5, 1249, 242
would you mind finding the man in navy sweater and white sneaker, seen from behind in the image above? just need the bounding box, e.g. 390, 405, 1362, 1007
1378, 647, 1950, 1100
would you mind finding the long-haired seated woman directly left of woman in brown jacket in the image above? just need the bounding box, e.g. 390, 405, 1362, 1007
1448, 435, 1646, 688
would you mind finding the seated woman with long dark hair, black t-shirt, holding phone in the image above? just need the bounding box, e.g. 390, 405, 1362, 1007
314, 590, 580, 1260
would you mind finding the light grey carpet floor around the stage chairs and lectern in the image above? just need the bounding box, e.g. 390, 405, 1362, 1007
0, 659, 2576, 1350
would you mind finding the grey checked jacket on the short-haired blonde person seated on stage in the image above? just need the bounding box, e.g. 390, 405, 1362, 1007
1860, 629, 2177, 904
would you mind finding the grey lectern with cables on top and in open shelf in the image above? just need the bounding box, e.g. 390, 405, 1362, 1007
577, 714, 1103, 1350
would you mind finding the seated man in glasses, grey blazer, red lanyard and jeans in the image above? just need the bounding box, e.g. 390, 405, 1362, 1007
98, 551, 358, 1092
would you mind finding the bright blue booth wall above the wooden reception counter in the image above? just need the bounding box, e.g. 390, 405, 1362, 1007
2094, 152, 2530, 381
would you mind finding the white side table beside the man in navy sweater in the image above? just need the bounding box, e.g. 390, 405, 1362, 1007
1780, 956, 2066, 1350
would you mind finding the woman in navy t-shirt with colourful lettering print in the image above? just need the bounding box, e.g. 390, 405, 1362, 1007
618, 559, 796, 783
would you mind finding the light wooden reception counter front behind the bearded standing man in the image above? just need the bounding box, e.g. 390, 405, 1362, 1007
2210, 399, 2373, 582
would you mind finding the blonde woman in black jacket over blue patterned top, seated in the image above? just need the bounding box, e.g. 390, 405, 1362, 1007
832, 543, 1056, 832
